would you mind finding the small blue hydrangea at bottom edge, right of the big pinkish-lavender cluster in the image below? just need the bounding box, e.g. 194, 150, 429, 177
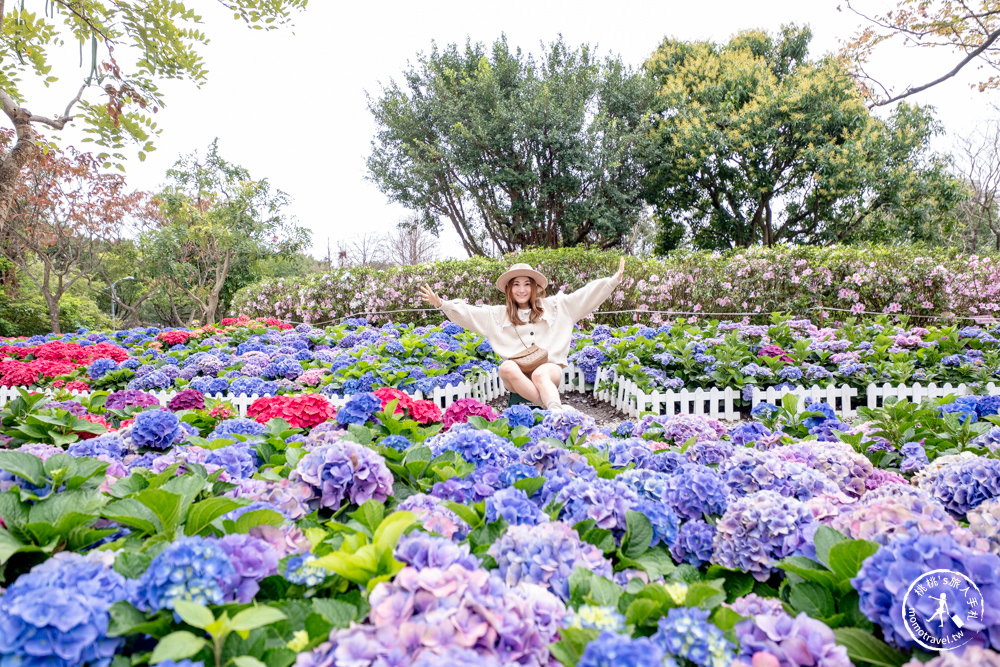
652, 607, 736, 667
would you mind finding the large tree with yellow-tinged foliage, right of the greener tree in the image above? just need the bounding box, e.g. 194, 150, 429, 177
645, 26, 953, 251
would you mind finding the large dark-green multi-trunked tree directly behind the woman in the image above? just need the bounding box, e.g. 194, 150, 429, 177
368, 37, 649, 255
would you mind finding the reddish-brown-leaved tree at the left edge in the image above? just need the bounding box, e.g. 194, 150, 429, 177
0, 140, 148, 333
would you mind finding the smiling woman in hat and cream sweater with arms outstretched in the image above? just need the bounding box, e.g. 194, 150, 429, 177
420, 258, 625, 410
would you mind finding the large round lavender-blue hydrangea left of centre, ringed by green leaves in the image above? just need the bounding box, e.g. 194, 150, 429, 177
290, 440, 393, 510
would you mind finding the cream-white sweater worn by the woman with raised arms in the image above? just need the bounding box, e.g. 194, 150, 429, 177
441, 276, 620, 366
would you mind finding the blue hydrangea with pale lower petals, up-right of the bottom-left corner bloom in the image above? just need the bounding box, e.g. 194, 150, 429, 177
131, 537, 236, 611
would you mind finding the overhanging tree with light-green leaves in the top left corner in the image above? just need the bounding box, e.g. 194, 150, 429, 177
0, 0, 307, 229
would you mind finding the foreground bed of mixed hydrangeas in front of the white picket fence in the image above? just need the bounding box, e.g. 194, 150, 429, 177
0, 370, 1000, 667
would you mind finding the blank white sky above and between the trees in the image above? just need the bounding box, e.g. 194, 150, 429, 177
15, 0, 997, 257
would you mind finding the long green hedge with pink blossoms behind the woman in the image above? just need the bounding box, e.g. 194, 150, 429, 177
233, 246, 1000, 323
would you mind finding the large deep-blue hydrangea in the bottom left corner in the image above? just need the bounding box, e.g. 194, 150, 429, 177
0, 552, 127, 667
